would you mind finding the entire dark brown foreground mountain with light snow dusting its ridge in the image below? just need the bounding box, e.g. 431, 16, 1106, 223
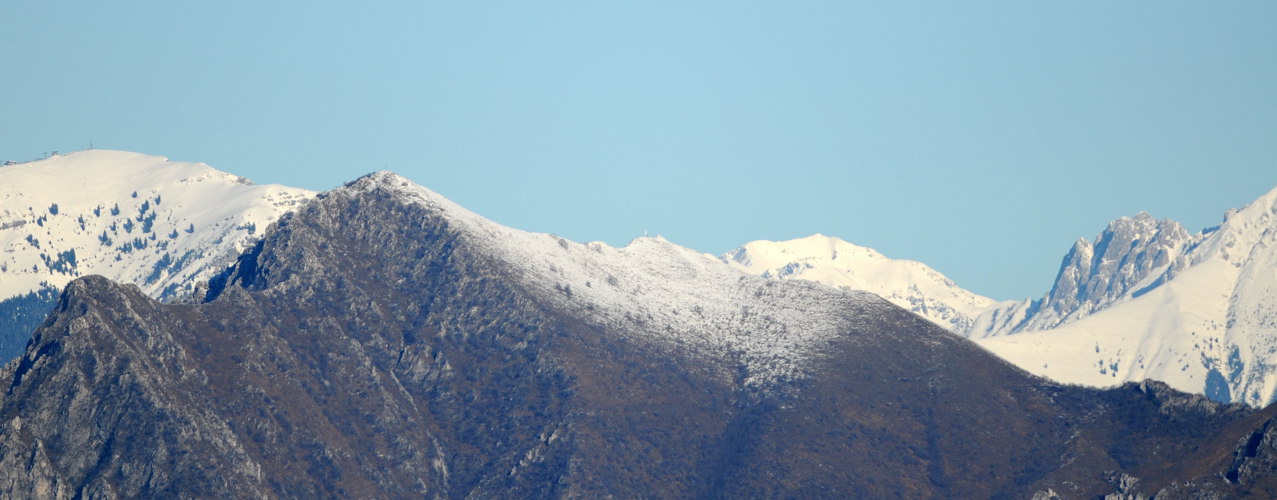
0, 173, 1277, 497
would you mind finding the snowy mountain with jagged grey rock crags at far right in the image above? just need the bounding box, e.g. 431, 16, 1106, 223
972, 181, 1277, 404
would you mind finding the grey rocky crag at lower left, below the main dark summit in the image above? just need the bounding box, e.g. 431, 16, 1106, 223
4, 277, 269, 497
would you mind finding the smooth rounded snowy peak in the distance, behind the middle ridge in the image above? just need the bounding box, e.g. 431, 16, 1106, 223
722, 233, 995, 332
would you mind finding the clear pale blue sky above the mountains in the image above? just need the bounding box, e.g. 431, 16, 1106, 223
0, 0, 1277, 298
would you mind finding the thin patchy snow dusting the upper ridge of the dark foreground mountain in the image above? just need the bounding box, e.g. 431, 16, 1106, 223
350, 172, 891, 388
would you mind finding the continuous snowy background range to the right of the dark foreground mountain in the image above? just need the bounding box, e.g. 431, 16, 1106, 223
723, 184, 1277, 406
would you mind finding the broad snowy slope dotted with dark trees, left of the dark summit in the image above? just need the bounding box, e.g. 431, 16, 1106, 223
0, 149, 314, 300
